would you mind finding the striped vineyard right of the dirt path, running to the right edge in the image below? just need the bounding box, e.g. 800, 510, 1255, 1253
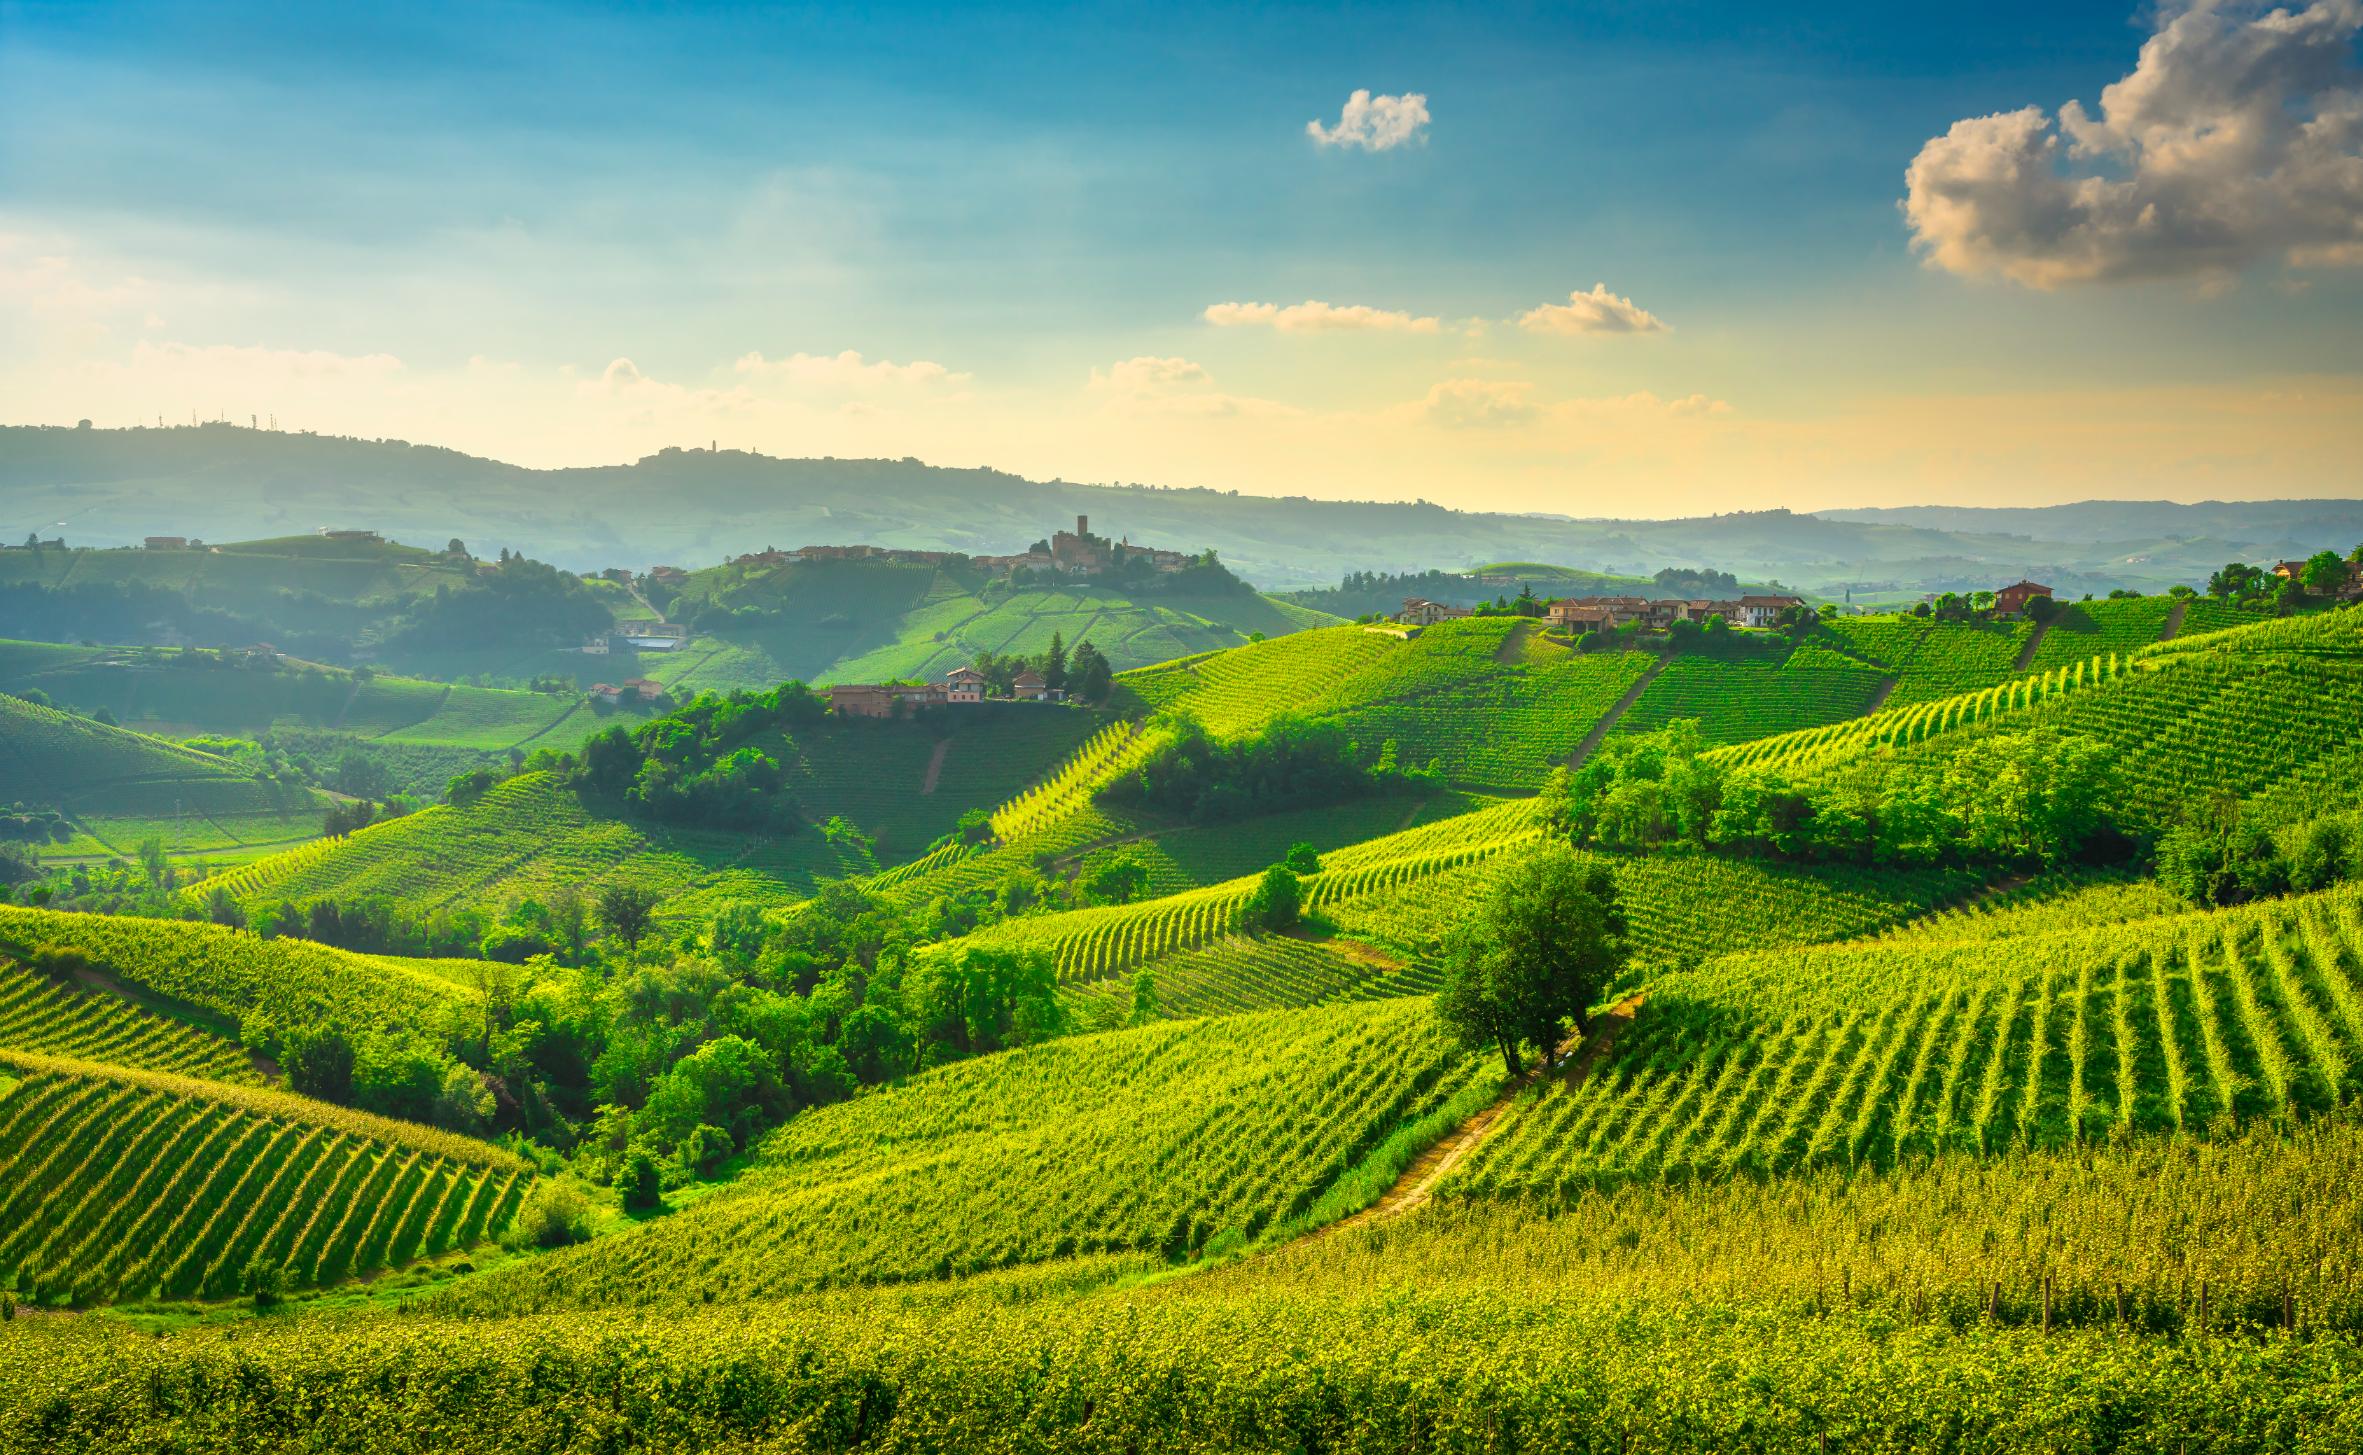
1463, 888, 2363, 1198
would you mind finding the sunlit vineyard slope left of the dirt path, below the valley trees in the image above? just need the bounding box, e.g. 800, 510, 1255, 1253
451, 1001, 1498, 1313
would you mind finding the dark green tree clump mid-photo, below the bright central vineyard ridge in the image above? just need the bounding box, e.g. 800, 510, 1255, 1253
1104, 716, 1437, 822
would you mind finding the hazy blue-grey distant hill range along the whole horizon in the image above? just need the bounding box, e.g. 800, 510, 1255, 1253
0, 425, 2363, 600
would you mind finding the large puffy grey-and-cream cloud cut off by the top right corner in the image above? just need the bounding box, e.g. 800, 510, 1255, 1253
1902, 0, 2363, 288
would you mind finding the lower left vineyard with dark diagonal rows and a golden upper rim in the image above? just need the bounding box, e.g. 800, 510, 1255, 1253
0, 1051, 529, 1304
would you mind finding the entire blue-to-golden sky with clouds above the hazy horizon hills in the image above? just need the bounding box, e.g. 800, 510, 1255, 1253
0, 0, 2363, 517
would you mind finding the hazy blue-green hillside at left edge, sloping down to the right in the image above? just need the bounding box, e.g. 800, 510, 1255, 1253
0, 694, 324, 857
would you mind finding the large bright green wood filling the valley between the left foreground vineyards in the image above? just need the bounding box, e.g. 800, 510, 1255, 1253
196, 883, 1070, 1183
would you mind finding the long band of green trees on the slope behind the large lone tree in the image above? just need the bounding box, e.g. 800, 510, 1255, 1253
1543, 720, 2129, 864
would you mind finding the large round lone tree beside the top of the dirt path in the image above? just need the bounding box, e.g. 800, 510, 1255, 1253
1437, 846, 1626, 1077
